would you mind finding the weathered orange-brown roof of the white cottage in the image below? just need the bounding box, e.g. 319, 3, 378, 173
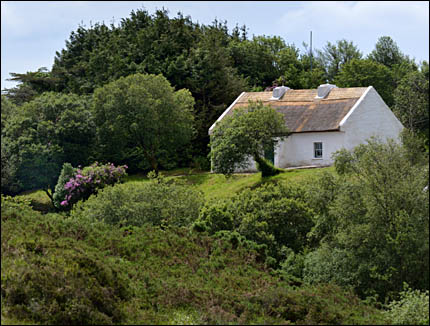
227, 87, 367, 132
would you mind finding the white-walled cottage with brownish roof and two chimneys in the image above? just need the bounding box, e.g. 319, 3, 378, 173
209, 84, 403, 172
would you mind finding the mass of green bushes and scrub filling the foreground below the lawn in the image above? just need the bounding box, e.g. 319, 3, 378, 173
2, 140, 429, 324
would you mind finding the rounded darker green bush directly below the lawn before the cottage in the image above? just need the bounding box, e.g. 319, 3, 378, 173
194, 184, 313, 261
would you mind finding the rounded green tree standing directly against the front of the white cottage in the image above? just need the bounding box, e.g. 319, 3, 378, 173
210, 102, 288, 176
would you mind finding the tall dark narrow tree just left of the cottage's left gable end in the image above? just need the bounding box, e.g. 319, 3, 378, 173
185, 21, 247, 156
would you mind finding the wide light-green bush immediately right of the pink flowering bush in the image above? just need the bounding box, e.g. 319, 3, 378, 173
72, 172, 202, 226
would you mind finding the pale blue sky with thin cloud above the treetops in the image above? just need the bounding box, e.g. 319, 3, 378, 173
1, 1, 429, 89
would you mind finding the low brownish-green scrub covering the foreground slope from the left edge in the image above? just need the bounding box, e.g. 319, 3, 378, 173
1, 196, 383, 324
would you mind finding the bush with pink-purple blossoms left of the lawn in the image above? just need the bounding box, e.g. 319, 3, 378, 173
55, 162, 128, 209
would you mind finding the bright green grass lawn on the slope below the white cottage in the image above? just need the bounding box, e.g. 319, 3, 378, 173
20, 167, 334, 212
